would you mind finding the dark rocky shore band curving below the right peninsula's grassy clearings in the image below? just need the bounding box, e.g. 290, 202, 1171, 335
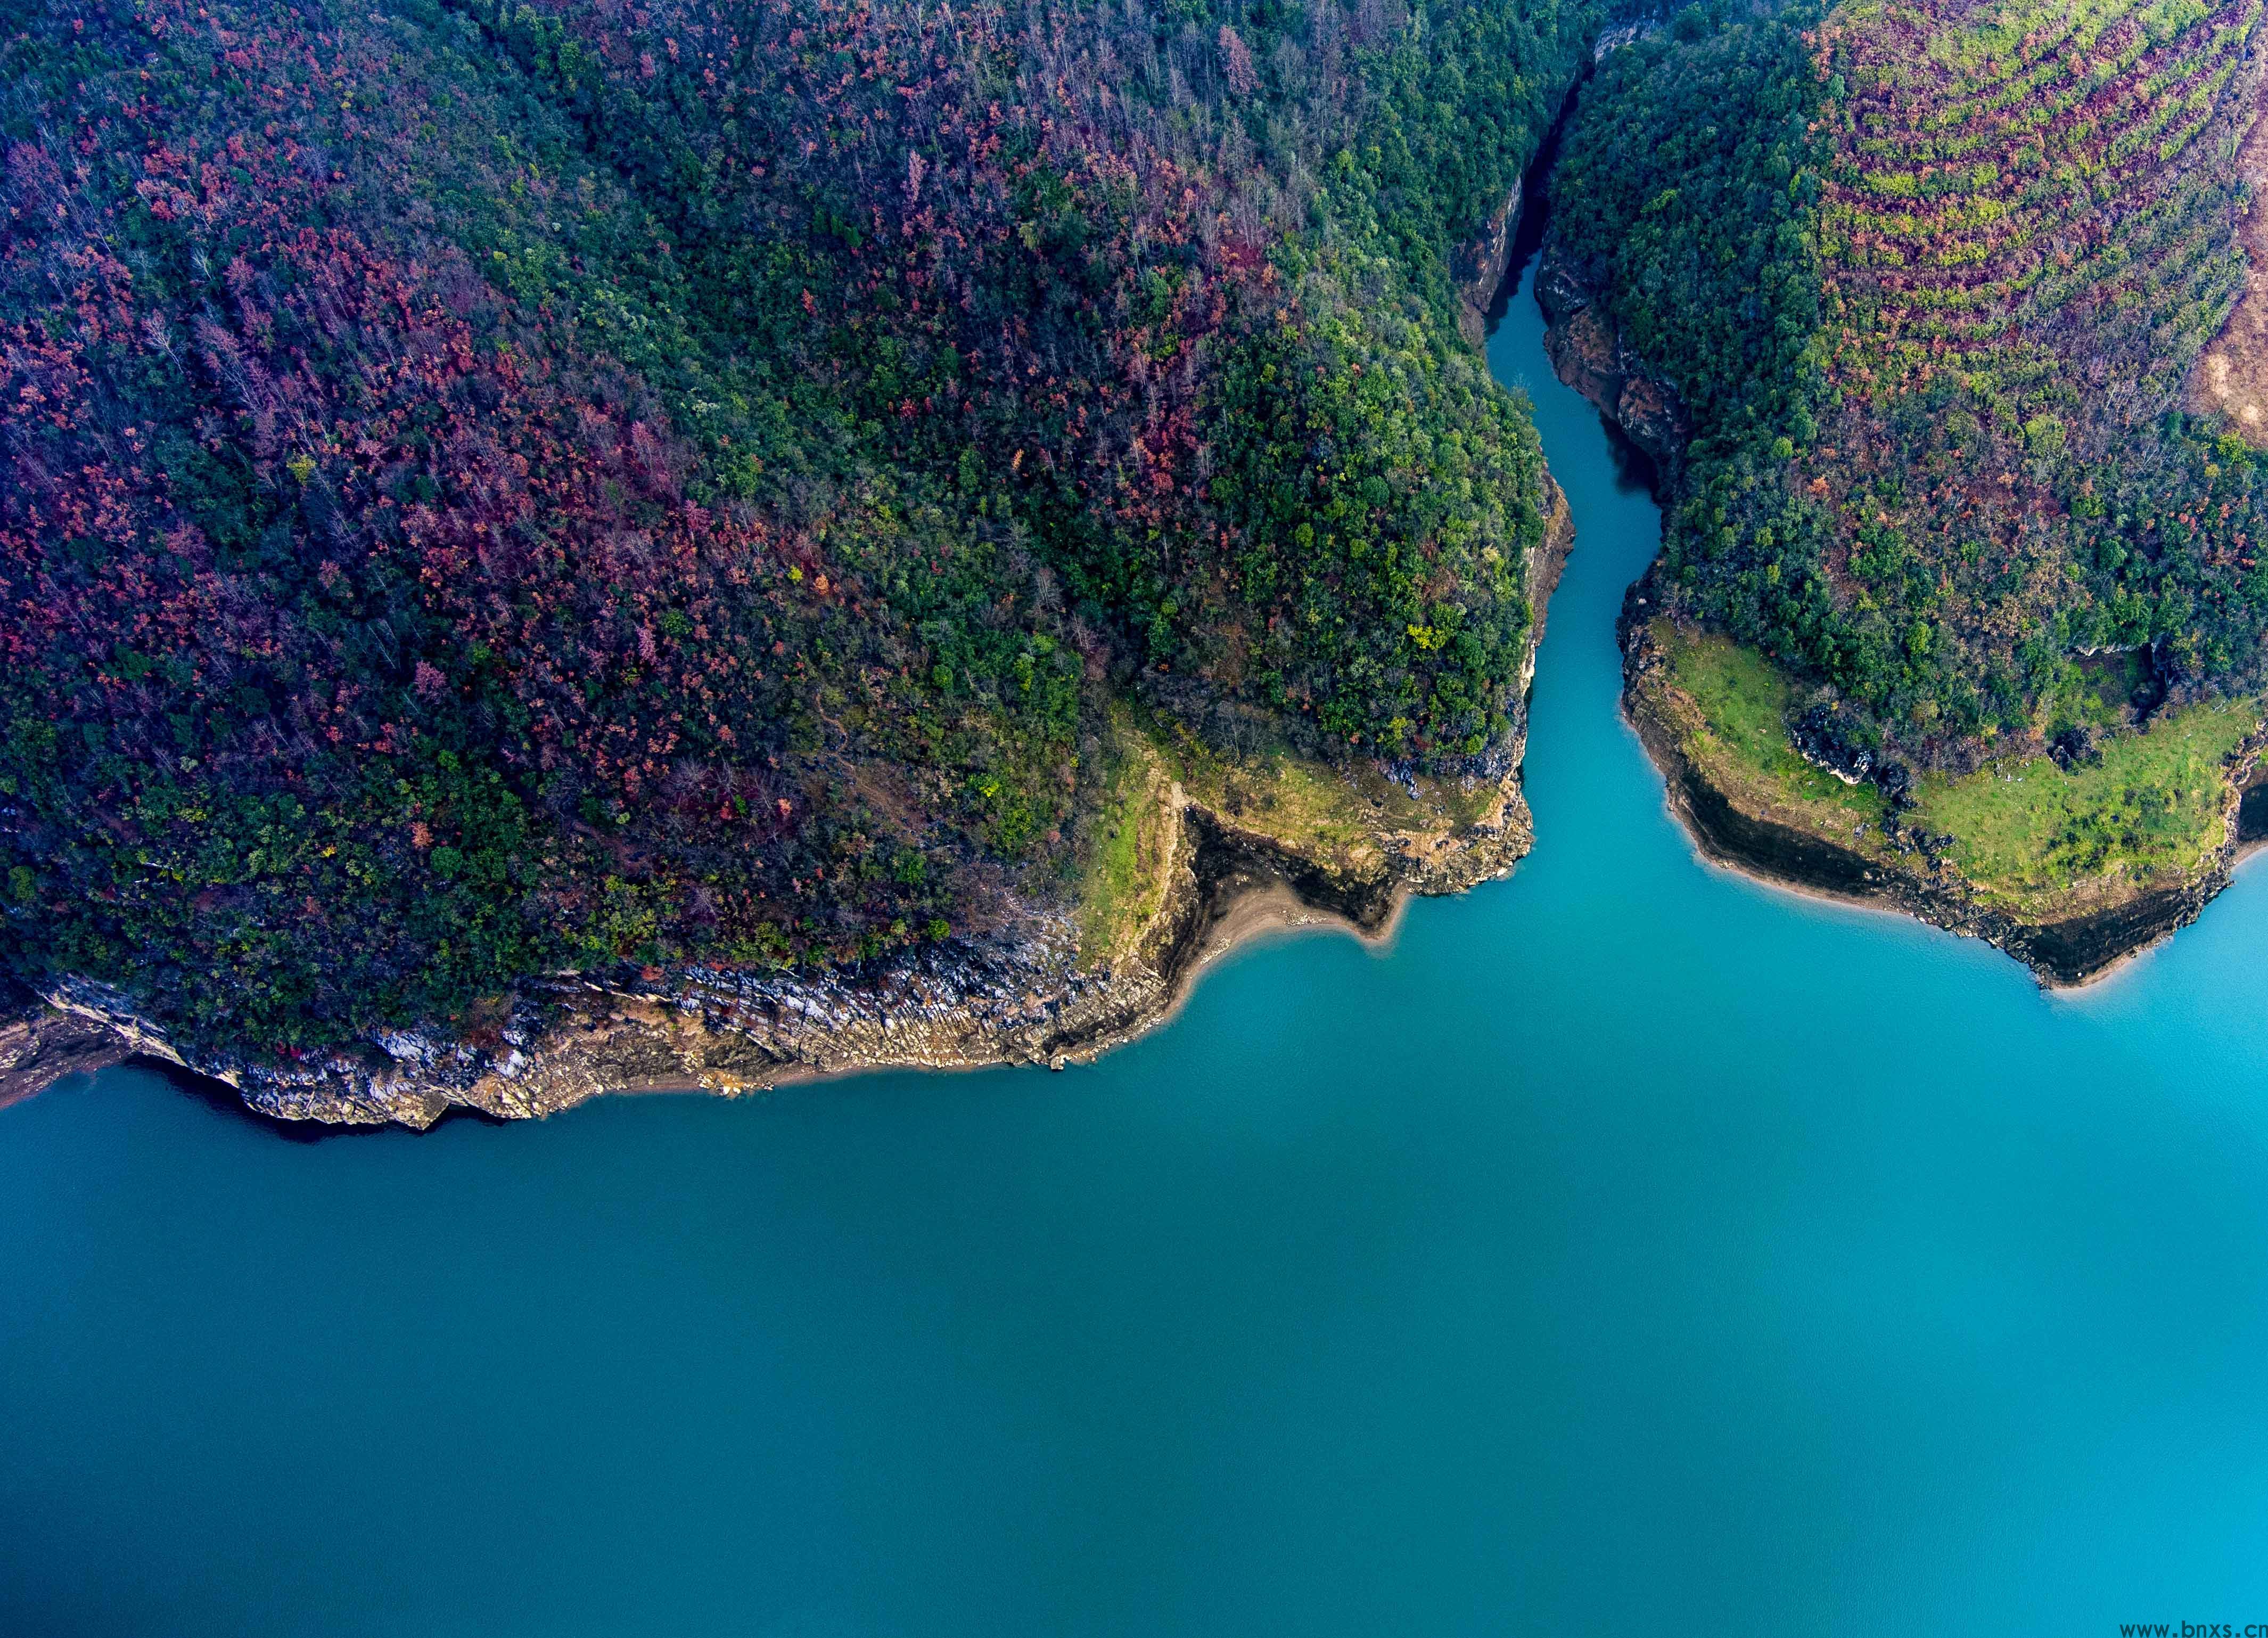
1620, 603, 2268, 987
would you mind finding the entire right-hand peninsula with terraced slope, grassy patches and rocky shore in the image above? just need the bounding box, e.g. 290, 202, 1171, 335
1542, 0, 2268, 982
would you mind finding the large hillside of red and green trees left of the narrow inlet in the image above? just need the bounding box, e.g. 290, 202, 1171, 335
0, 0, 1599, 1051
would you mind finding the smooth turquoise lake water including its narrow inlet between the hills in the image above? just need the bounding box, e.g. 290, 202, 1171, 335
0, 248, 2268, 1638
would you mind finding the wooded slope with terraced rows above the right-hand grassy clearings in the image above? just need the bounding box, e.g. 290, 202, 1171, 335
1554, 0, 2268, 767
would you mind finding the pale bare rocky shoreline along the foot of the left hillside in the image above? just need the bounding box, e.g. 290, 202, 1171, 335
0, 501, 1572, 1130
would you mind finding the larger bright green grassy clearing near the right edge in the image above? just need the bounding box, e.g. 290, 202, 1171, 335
1914, 701, 2259, 912
